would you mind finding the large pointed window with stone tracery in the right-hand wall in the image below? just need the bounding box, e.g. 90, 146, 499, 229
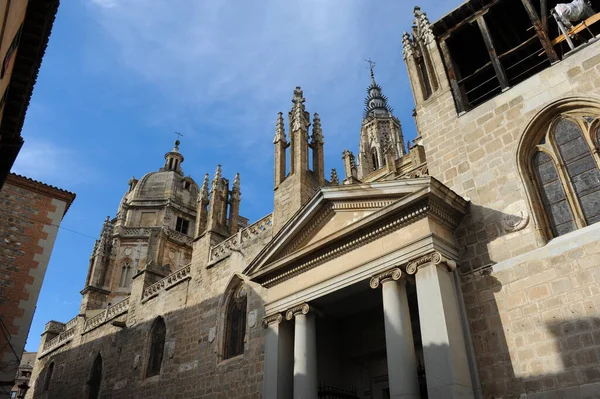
531, 115, 600, 237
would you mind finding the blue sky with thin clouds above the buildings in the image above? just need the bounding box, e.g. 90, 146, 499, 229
13, 0, 459, 351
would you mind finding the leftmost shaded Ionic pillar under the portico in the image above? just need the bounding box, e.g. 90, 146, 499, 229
262, 313, 294, 399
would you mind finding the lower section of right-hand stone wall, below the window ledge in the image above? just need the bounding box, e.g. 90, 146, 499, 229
462, 225, 600, 398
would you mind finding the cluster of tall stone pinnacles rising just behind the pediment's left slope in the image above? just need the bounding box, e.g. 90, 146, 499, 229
273, 87, 325, 232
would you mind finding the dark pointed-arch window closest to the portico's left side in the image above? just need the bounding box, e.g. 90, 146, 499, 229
223, 283, 247, 359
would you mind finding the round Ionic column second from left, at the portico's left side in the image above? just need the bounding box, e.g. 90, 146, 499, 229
285, 303, 318, 399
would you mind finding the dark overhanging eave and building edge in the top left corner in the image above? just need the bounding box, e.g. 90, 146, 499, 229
0, 0, 59, 188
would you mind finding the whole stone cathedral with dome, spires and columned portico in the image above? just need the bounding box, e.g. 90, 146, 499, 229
27, 0, 600, 399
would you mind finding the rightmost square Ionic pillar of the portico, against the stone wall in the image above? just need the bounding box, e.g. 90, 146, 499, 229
406, 252, 473, 399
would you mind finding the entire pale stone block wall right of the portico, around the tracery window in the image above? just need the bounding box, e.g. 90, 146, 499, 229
417, 35, 600, 398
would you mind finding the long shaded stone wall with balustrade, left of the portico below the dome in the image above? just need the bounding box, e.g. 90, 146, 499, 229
27, 220, 272, 399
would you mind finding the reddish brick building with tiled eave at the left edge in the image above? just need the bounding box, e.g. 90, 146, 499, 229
0, 173, 75, 397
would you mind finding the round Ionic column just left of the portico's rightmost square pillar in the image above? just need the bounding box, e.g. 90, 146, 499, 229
371, 268, 420, 399
